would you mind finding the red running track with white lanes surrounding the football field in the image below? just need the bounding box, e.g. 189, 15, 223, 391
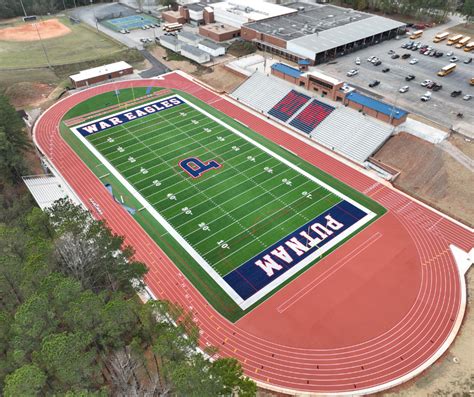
34, 73, 473, 393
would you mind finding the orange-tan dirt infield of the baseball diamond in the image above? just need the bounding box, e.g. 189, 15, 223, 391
0, 19, 71, 41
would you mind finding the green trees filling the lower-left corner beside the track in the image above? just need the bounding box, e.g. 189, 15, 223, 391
0, 96, 256, 397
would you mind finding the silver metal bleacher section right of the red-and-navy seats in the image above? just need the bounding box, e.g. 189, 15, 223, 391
311, 107, 392, 163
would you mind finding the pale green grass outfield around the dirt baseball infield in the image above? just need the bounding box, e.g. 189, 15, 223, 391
0, 18, 125, 69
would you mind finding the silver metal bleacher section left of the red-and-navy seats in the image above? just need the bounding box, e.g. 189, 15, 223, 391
231, 72, 291, 113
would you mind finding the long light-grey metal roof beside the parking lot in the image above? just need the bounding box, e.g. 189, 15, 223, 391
288, 15, 405, 58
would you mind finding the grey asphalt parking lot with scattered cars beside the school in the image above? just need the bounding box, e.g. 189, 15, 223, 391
316, 27, 474, 131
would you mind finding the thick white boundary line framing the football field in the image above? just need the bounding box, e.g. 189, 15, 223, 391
71, 94, 376, 310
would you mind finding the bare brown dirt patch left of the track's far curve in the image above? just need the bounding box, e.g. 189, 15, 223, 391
5, 82, 56, 109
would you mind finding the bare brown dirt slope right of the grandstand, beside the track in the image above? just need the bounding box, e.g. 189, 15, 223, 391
374, 132, 474, 226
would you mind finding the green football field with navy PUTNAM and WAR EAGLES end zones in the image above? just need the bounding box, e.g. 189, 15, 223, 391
66, 90, 379, 310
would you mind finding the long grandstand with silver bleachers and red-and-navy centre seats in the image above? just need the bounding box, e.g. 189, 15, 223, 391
231, 72, 392, 164
